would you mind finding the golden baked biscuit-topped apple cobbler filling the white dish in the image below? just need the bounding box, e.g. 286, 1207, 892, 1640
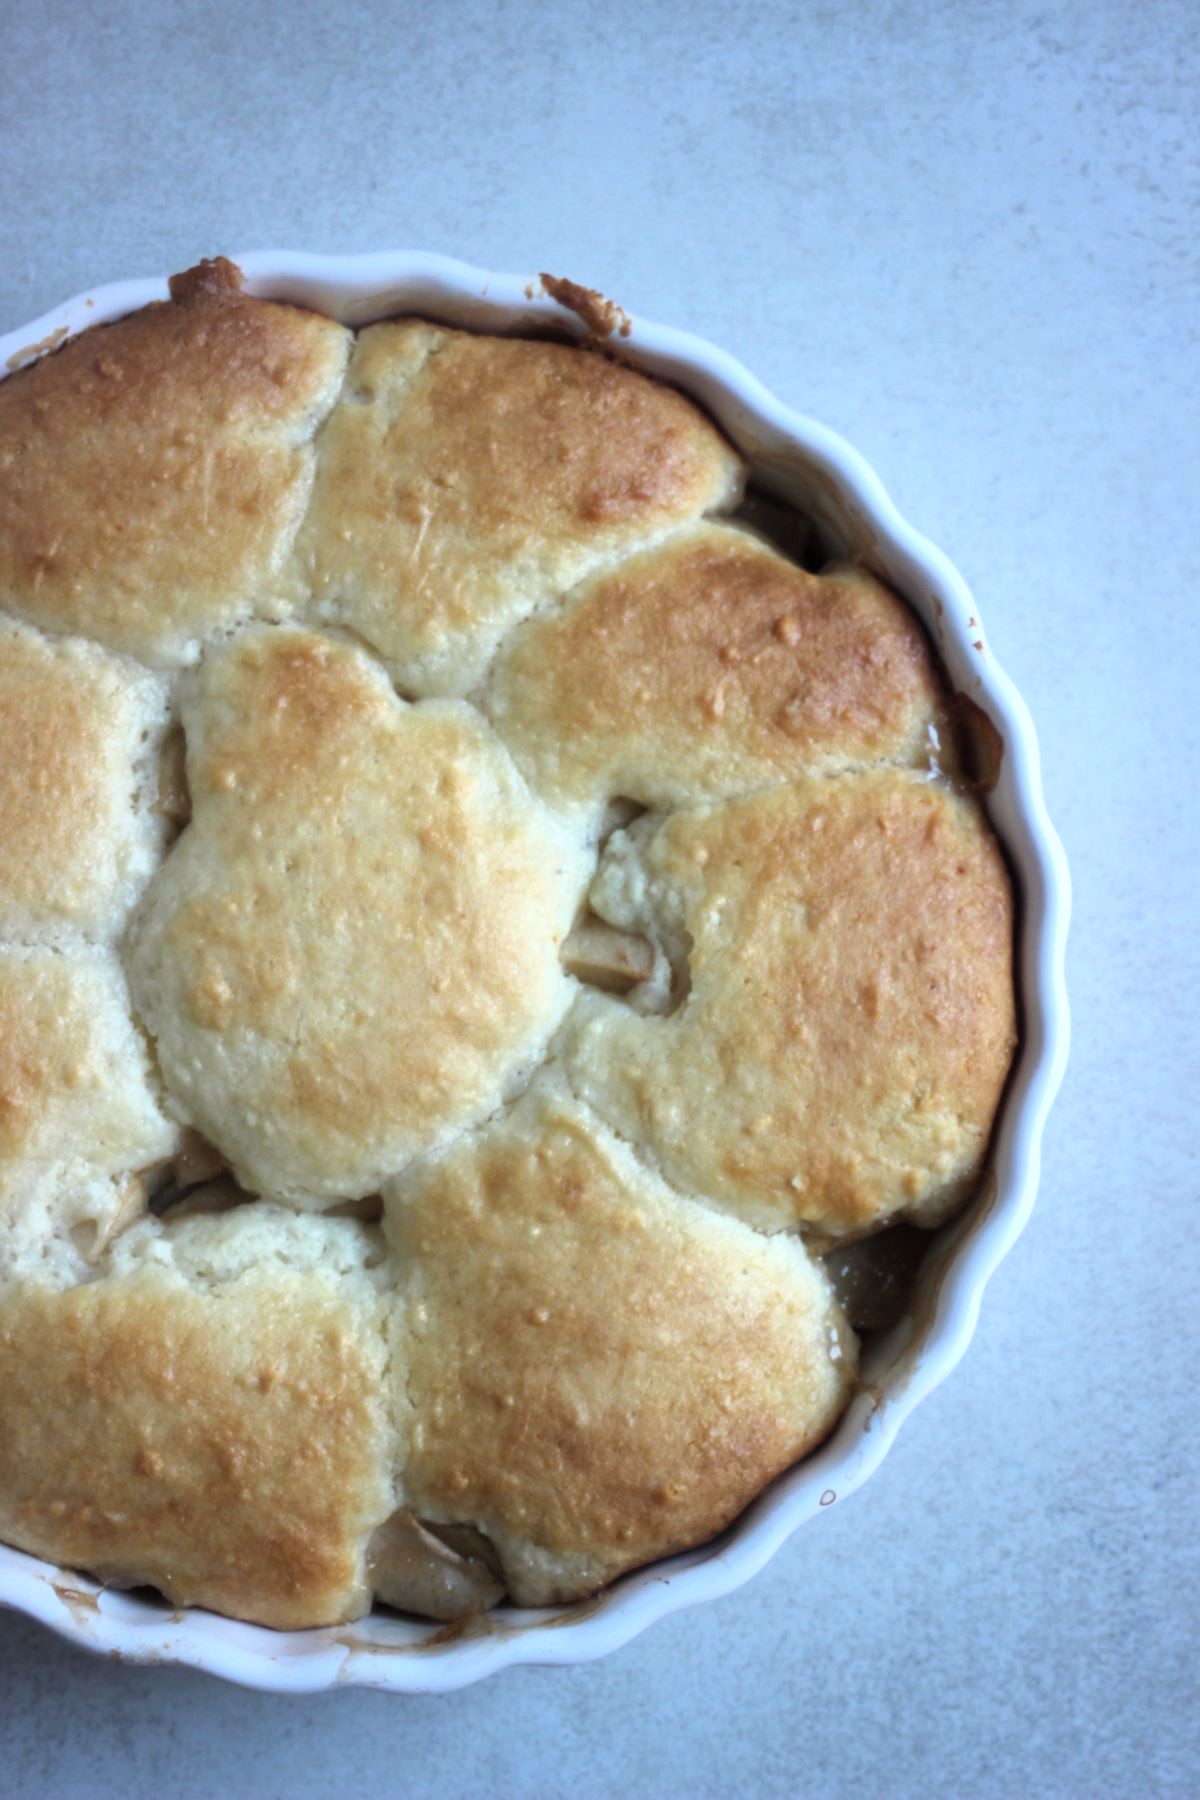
0, 261, 1015, 1627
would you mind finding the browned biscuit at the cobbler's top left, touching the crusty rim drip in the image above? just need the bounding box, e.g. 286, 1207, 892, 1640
0, 259, 349, 664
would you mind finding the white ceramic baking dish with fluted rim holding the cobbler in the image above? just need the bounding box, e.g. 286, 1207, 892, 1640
0, 250, 1069, 1694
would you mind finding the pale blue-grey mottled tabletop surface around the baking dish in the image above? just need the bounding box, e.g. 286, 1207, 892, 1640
0, 0, 1200, 1796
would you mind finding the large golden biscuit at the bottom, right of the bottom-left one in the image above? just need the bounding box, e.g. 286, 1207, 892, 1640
387, 1082, 855, 1606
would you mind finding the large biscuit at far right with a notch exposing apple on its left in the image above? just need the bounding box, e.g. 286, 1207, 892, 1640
569, 769, 1015, 1237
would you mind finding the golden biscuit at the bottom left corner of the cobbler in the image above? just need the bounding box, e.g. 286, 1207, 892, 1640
0, 1208, 396, 1629
